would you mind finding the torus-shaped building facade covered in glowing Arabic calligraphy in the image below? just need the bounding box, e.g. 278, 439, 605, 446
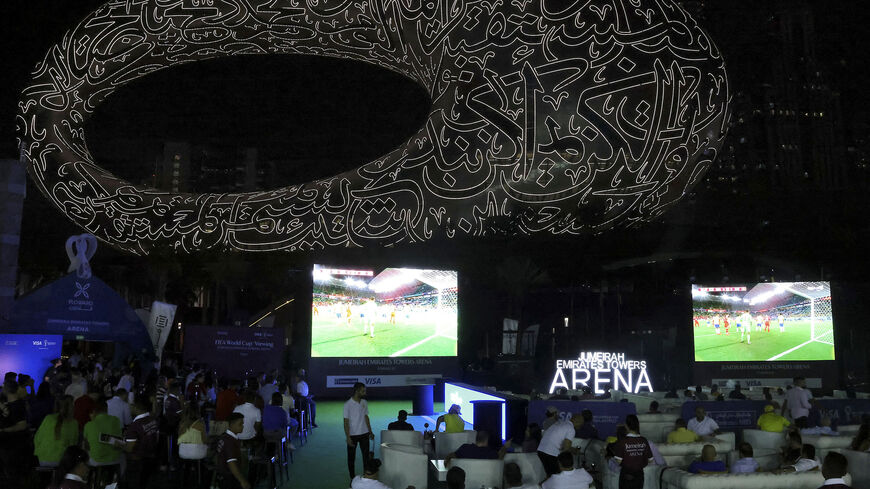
17, 0, 730, 254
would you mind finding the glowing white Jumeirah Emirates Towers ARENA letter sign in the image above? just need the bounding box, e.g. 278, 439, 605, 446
550, 351, 653, 394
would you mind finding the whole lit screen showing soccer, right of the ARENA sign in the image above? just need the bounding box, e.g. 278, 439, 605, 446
692, 282, 834, 362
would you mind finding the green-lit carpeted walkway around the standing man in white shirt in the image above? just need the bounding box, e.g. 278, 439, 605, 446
281, 400, 443, 489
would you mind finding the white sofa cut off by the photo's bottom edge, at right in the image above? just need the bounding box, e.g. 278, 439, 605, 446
661, 468, 858, 489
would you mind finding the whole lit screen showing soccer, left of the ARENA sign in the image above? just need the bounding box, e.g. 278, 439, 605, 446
311, 265, 457, 357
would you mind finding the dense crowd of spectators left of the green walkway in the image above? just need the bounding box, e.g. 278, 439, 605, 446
0, 353, 316, 489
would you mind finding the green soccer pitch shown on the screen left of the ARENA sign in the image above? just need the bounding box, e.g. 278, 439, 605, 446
311, 315, 456, 357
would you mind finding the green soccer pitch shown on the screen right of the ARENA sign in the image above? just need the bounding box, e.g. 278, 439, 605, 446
694, 321, 834, 362
